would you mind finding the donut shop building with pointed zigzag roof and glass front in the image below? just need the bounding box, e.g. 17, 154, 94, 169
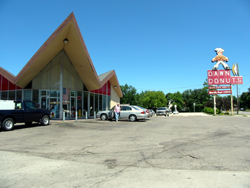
0, 13, 122, 119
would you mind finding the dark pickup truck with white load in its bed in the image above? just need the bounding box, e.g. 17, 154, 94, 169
0, 100, 51, 131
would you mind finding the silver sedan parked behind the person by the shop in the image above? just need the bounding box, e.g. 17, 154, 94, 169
96, 105, 147, 121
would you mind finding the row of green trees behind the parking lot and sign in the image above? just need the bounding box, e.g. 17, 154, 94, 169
121, 82, 250, 112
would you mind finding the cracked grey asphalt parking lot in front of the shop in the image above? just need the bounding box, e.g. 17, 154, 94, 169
0, 116, 250, 188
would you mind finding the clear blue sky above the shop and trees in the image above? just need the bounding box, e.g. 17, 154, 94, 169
0, 0, 250, 95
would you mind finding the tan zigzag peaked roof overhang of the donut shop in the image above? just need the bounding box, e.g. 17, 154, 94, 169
0, 12, 122, 97
